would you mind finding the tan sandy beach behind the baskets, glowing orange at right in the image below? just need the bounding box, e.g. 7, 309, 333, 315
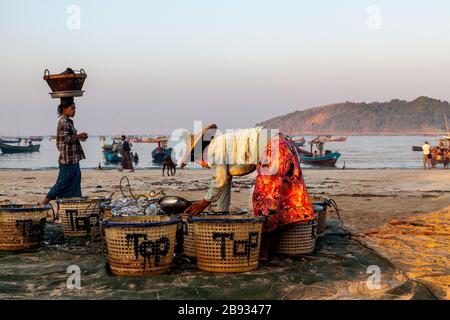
0, 170, 450, 299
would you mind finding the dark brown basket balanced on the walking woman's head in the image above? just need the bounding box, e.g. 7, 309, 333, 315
44, 68, 87, 98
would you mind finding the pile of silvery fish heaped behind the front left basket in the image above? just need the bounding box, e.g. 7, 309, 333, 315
110, 197, 161, 217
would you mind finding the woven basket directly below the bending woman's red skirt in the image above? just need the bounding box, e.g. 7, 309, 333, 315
276, 208, 319, 255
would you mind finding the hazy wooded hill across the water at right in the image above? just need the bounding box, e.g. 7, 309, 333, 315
257, 97, 450, 135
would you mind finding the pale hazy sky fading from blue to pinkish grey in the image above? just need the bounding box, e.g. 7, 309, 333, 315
0, 0, 450, 135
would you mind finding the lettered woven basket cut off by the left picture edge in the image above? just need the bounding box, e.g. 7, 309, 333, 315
0, 204, 51, 251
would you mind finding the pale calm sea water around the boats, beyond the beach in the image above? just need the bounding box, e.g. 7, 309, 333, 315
0, 136, 439, 169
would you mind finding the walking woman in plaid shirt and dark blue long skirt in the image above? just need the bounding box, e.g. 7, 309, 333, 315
41, 98, 88, 205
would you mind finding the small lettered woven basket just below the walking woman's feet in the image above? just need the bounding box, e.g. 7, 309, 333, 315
57, 197, 111, 237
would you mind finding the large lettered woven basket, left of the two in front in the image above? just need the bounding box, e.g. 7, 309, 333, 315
102, 216, 180, 276
